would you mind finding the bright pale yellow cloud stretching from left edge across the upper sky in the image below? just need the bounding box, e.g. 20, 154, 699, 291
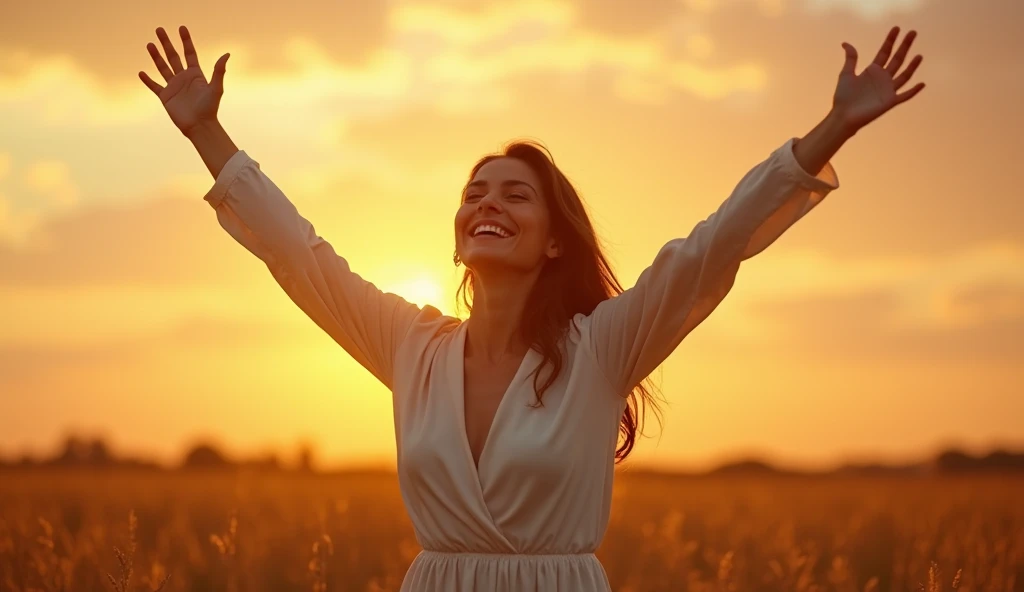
0, 0, 763, 243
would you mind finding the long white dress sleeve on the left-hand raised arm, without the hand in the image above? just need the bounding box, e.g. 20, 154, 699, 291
203, 151, 421, 389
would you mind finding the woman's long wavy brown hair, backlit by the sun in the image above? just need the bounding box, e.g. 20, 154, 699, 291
453, 140, 660, 463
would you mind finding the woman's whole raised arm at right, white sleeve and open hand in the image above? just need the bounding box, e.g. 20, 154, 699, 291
586, 27, 925, 401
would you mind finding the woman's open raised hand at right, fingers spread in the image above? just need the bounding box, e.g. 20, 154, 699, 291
833, 27, 925, 133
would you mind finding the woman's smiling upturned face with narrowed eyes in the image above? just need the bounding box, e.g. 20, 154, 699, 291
455, 157, 558, 271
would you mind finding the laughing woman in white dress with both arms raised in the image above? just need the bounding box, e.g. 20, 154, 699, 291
139, 27, 925, 591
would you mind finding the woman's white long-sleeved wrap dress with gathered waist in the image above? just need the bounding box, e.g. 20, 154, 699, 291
204, 138, 839, 592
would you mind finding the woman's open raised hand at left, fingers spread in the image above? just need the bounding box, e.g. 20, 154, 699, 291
138, 26, 230, 135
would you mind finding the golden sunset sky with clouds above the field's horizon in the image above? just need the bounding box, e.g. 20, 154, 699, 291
0, 0, 1024, 468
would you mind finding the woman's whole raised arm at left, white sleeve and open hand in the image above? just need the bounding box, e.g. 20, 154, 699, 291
139, 27, 428, 389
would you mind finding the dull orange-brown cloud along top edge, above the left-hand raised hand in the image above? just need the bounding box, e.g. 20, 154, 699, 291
0, 0, 389, 85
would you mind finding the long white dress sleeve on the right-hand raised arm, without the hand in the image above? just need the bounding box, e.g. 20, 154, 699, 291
585, 138, 839, 394
